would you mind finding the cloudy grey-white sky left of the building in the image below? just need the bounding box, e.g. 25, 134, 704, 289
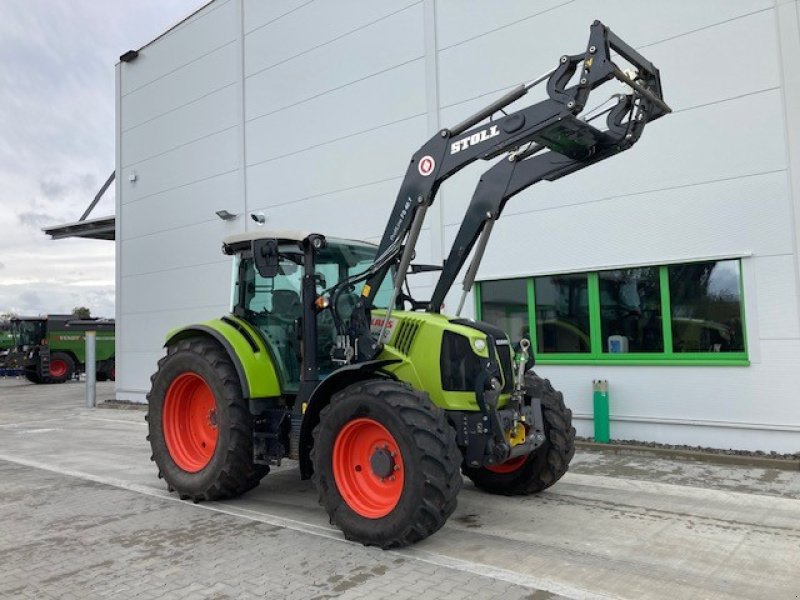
0, 0, 205, 317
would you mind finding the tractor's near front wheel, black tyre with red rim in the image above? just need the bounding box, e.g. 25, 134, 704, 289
311, 380, 462, 549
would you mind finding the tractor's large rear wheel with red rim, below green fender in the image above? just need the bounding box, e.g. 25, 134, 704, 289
145, 338, 269, 502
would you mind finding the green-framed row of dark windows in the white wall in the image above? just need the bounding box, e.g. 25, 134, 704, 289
476, 260, 748, 364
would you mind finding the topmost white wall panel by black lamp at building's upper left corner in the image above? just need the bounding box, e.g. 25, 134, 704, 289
122, 0, 239, 95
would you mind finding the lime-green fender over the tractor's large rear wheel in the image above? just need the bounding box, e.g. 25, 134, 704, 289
165, 316, 281, 398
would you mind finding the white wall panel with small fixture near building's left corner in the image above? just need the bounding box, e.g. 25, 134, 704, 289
122, 127, 241, 204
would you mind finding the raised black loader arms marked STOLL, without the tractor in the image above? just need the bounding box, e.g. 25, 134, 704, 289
344, 21, 670, 360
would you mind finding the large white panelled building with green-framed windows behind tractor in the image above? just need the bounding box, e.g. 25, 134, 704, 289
115, 0, 800, 452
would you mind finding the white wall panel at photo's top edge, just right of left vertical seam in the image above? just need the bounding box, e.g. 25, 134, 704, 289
245, 0, 417, 76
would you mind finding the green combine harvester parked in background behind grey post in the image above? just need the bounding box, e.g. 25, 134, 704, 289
6, 315, 116, 383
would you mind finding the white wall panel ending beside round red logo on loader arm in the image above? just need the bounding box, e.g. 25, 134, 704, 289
247, 116, 427, 206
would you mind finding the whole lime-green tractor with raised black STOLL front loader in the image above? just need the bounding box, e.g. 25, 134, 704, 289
148, 21, 670, 548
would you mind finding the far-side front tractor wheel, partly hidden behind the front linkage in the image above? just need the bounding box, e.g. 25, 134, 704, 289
463, 371, 575, 496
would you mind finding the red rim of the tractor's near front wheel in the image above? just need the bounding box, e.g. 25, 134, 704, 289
333, 418, 405, 519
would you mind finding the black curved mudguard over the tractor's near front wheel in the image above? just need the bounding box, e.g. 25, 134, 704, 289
300, 359, 400, 479
